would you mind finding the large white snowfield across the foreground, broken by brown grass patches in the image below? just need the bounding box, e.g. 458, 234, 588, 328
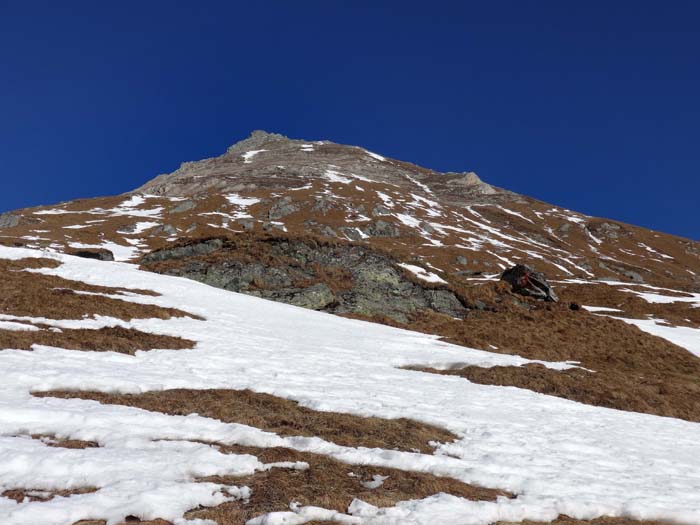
0, 247, 700, 525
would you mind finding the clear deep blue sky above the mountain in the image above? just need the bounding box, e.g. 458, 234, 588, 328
0, 0, 700, 239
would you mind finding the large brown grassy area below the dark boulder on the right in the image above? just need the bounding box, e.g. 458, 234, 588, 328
364, 283, 700, 421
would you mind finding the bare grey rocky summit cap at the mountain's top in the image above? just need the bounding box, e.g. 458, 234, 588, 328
135, 131, 504, 203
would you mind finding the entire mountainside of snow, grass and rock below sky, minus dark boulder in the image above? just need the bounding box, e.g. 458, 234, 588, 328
0, 132, 700, 525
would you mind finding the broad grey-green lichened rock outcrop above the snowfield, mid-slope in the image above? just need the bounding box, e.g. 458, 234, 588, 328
142, 235, 467, 323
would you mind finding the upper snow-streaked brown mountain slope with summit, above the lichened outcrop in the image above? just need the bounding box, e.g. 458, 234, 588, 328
0, 132, 700, 289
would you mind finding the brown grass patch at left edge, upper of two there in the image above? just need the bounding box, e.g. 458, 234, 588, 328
0, 259, 195, 321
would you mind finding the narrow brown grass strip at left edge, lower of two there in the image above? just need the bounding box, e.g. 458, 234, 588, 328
0, 326, 195, 355
